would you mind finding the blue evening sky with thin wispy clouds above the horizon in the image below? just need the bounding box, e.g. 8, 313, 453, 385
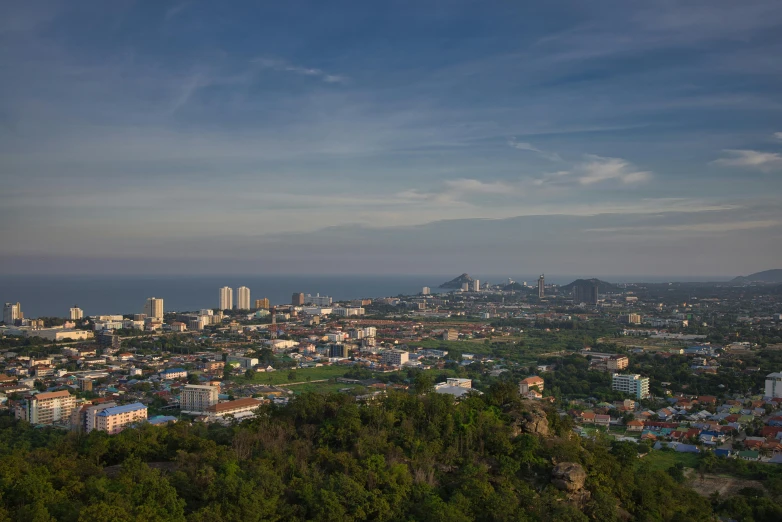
0, 0, 782, 277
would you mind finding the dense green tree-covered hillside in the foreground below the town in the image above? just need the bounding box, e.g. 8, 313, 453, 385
0, 383, 724, 522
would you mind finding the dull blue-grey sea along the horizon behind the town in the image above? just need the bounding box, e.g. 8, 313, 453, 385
0, 274, 736, 318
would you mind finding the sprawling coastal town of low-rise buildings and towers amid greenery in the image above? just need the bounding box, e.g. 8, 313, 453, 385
0, 274, 782, 464
